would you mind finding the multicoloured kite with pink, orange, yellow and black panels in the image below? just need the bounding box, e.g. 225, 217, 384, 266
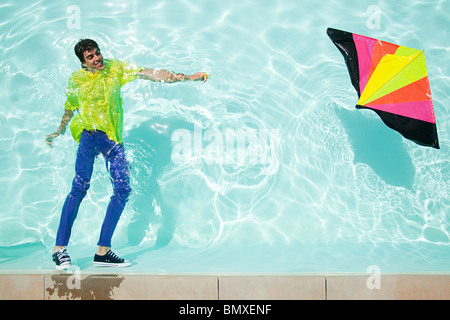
327, 28, 439, 149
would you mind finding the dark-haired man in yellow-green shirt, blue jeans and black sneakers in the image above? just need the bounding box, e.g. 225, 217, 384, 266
46, 39, 207, 269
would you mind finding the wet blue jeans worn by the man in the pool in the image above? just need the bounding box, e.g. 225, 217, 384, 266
56, 130, 131, 247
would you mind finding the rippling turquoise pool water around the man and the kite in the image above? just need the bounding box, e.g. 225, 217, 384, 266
0, 0, 450, 273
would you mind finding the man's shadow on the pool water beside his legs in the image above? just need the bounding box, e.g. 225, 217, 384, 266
125, 118, 189, 250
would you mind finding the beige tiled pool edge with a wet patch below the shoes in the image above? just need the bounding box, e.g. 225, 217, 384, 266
0, 273, 450, 300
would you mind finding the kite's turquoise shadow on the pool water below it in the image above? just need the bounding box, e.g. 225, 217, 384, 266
336, 108, 415, 189
